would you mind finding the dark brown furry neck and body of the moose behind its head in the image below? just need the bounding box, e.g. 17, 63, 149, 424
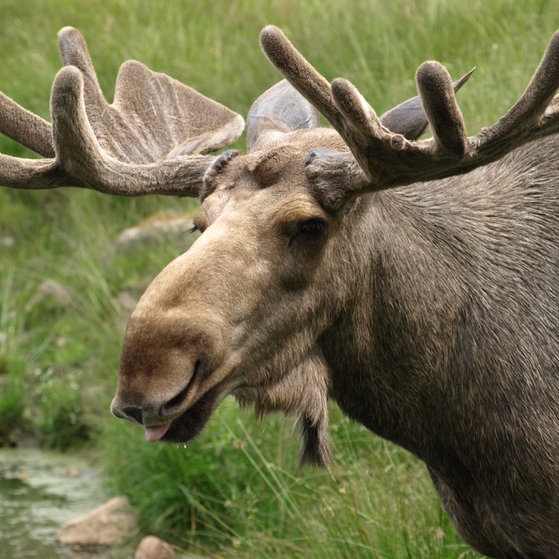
321, 136, 559, 559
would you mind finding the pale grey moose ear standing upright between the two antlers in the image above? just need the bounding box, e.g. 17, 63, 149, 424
247, 80, 320, 152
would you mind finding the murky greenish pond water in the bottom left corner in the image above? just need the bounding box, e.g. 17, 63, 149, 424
0, 449, 133, 559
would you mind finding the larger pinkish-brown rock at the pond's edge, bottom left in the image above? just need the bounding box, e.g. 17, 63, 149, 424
56, 497, 136, 547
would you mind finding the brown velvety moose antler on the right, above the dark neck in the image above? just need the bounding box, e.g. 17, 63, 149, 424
260, 26, 559, 208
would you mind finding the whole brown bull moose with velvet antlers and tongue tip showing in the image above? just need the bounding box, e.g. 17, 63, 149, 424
0, 26, 559, 559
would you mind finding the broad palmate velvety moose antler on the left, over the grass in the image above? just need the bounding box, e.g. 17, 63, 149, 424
0, 27, 244, 196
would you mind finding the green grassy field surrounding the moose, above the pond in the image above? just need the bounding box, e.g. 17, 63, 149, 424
0, 0, 559, 559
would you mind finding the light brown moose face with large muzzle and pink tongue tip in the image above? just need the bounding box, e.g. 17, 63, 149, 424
112, 136, 352, 460
